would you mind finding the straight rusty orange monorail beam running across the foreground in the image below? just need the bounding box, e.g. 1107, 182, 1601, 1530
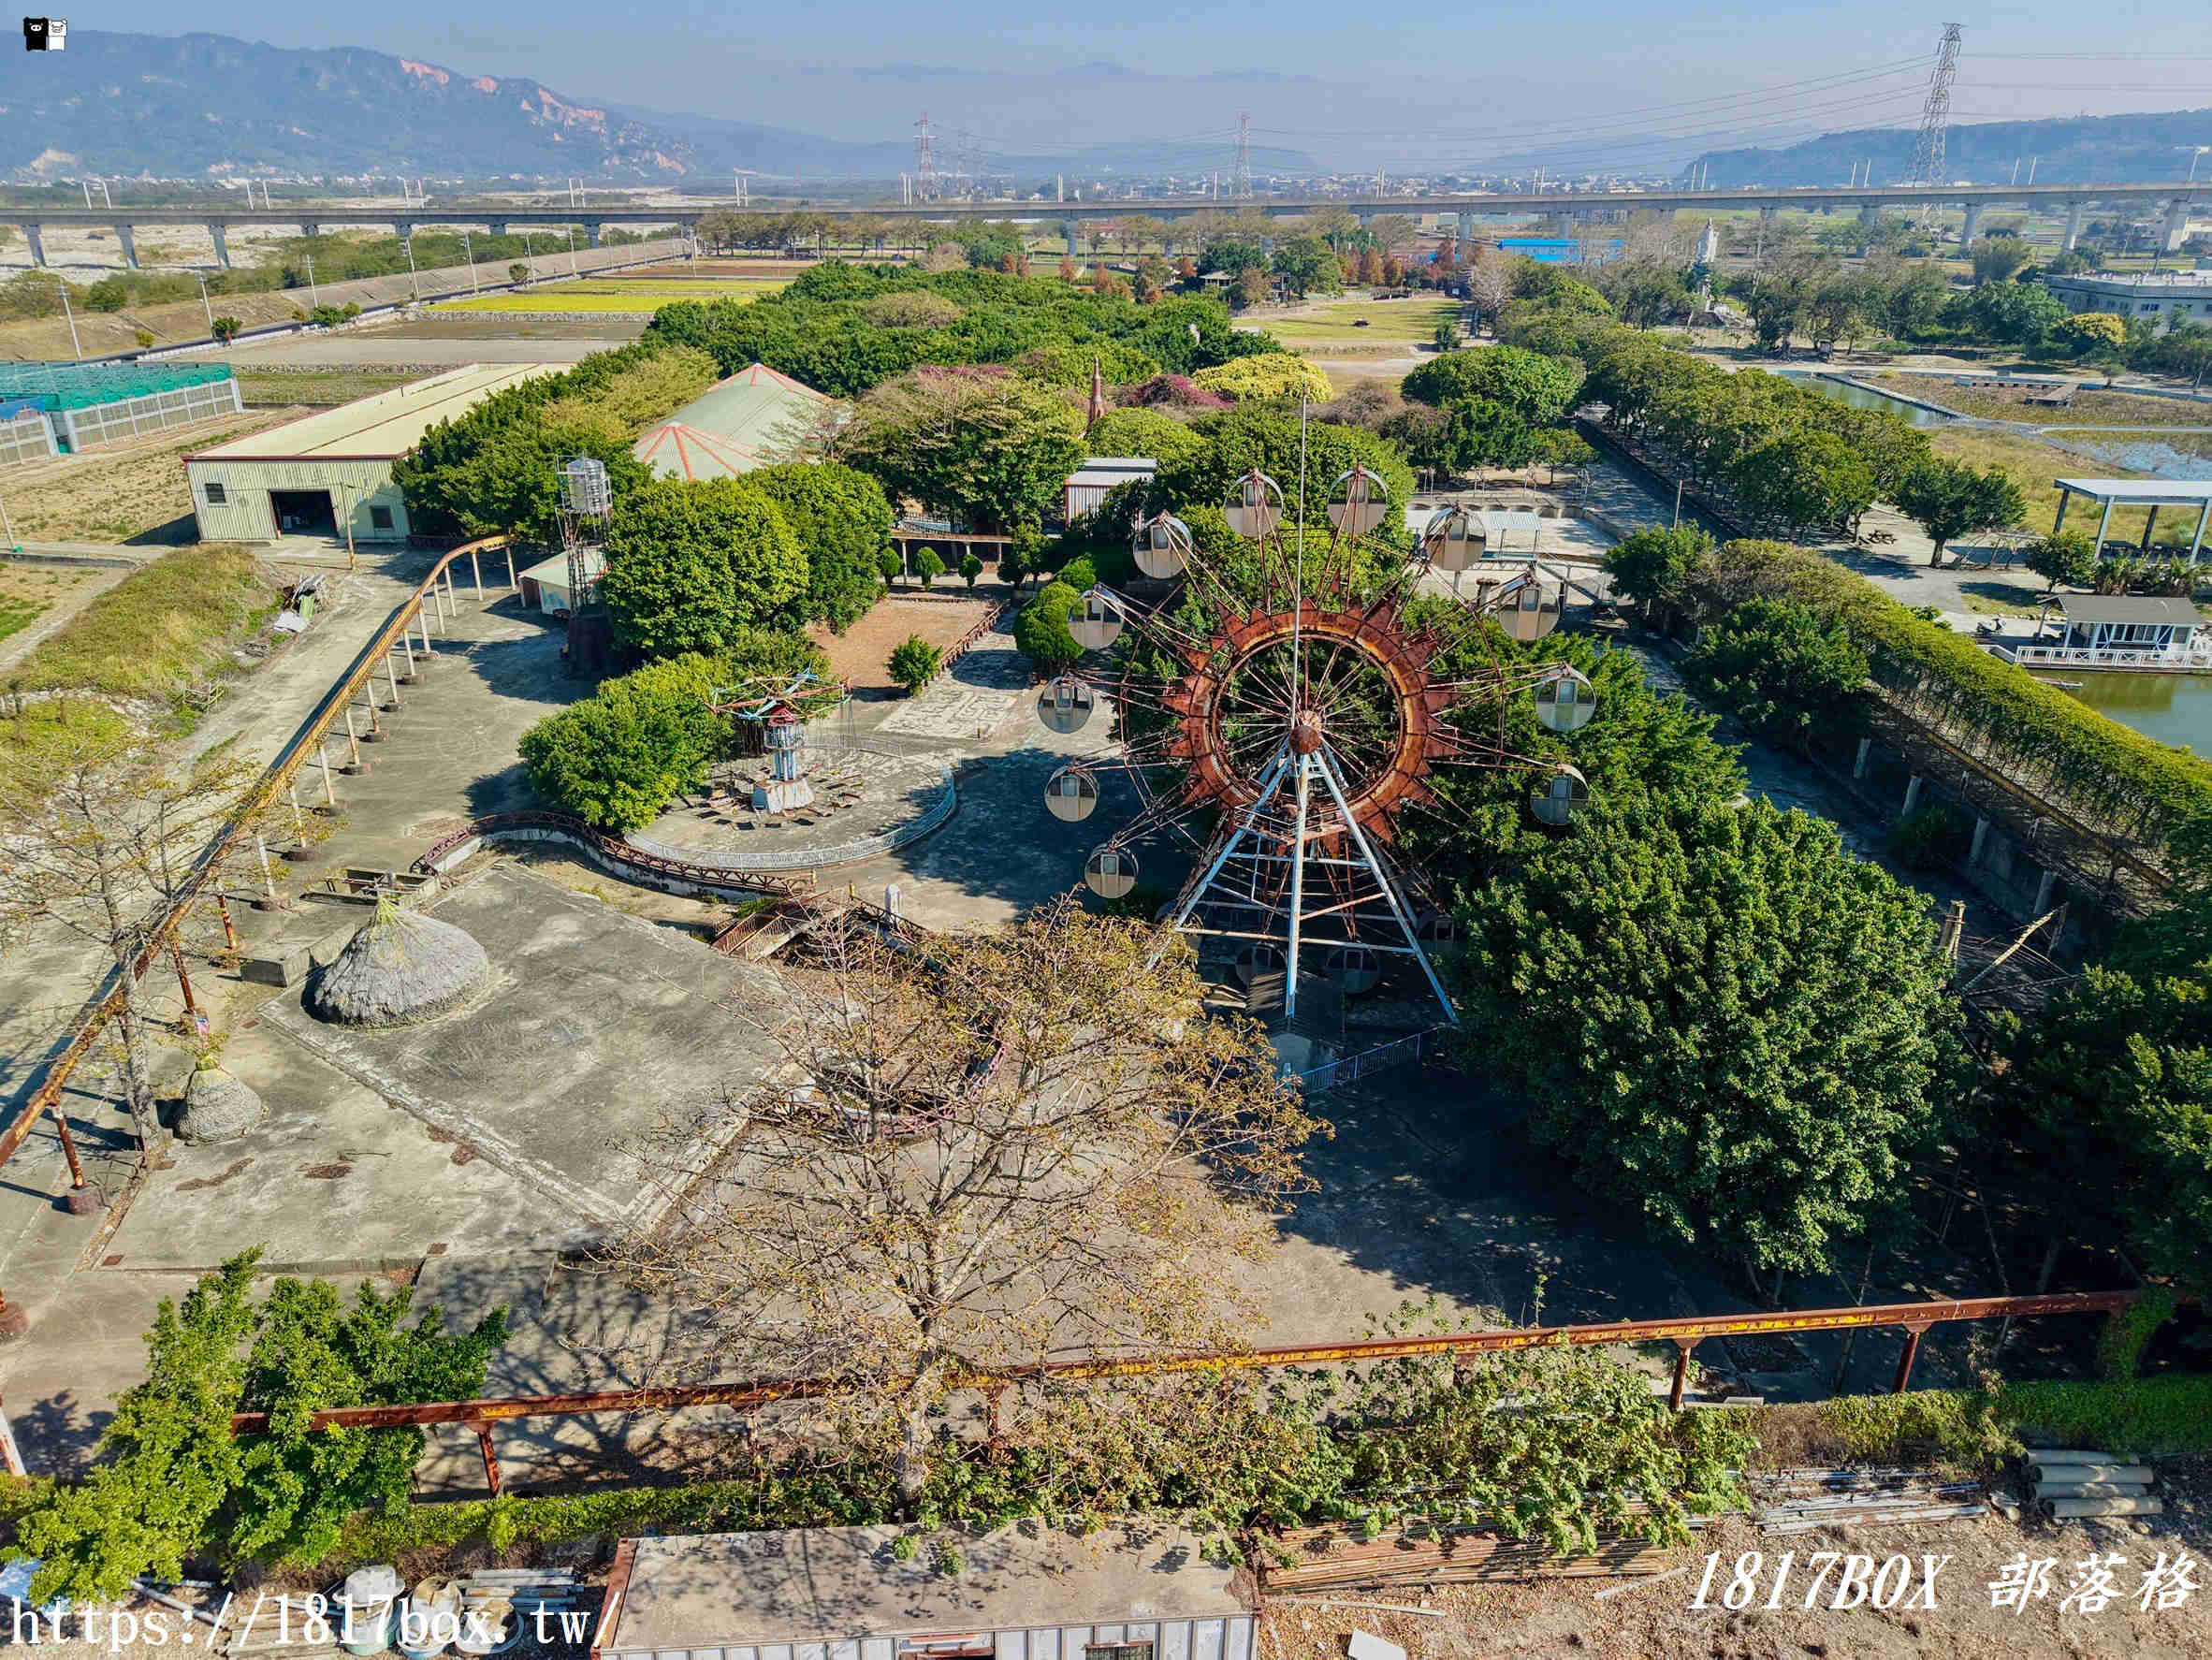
230, 1290, 2190, 1434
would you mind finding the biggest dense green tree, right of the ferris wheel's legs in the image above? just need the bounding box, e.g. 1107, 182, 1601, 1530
1453, 797, 1951, 1274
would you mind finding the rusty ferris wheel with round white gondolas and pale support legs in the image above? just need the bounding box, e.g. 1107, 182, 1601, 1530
1038, 467, 1594, 1023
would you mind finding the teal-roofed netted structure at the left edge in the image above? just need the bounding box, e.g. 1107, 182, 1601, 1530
0, 363, 245, 467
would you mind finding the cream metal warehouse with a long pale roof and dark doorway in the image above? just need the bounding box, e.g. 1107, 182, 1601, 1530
183, 363, 561, 543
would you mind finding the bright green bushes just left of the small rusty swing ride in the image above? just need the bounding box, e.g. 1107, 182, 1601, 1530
522, 629, 830, 835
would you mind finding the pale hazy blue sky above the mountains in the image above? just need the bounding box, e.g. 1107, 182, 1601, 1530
60, 0, 2212, 158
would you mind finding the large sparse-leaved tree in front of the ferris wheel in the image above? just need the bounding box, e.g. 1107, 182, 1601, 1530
621, 905, 1317, 1498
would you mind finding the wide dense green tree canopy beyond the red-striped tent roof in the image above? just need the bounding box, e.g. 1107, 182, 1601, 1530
646, 259, 1278, 399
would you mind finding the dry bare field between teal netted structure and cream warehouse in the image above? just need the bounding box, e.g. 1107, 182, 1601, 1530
7, 405, 308, 545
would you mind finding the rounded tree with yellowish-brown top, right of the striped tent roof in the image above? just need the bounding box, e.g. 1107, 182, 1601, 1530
838, 371, 1084, 529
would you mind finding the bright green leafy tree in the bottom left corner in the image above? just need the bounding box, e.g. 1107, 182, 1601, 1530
16, 1250, 506, 1600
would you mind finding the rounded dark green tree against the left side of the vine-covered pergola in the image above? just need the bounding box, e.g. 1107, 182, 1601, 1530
1681, 600, 1867, 755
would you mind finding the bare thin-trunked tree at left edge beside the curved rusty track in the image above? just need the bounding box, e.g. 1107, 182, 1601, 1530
0, 728, 281, 1146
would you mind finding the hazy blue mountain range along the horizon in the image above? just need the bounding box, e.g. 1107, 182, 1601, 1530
0, 26, 2212, 190
